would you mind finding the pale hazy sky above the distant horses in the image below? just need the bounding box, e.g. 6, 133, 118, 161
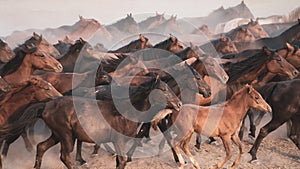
0, 0, 300, 36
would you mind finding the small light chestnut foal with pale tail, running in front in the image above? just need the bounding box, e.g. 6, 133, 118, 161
153, 85, 272, 169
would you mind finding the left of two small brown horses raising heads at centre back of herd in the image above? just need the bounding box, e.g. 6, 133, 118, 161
108, 34, 152, 53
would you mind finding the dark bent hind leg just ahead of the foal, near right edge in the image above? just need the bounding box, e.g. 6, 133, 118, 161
249, 119, 286, 161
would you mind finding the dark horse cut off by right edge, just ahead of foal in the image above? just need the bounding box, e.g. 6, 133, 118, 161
249, 79, 300, 160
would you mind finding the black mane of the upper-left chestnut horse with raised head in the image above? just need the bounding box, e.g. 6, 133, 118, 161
0, 46, 37, 77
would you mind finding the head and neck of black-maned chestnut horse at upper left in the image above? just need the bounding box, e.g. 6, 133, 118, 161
0, 45, 62, 86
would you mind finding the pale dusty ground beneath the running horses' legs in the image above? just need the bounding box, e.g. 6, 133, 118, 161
3, 115, 300, 169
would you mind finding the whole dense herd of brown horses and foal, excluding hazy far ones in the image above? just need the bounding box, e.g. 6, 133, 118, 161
0, 17, 300, 169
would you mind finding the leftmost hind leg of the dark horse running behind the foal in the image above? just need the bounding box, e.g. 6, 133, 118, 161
33, 134, 59, 169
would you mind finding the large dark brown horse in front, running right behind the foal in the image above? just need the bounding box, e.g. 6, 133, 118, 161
7, 74, 182, 169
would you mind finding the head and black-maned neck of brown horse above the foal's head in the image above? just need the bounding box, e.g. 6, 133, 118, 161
227, 47, 299, 85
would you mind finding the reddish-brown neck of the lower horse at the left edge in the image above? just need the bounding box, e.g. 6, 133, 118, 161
0, 87, 35, 126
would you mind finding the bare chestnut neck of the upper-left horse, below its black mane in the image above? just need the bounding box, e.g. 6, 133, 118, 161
3, 56, 36, 85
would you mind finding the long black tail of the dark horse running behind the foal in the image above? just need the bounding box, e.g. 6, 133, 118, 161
0, 102, 46, 141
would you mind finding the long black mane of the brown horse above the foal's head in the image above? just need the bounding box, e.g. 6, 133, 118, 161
227, 51, 269, 84
